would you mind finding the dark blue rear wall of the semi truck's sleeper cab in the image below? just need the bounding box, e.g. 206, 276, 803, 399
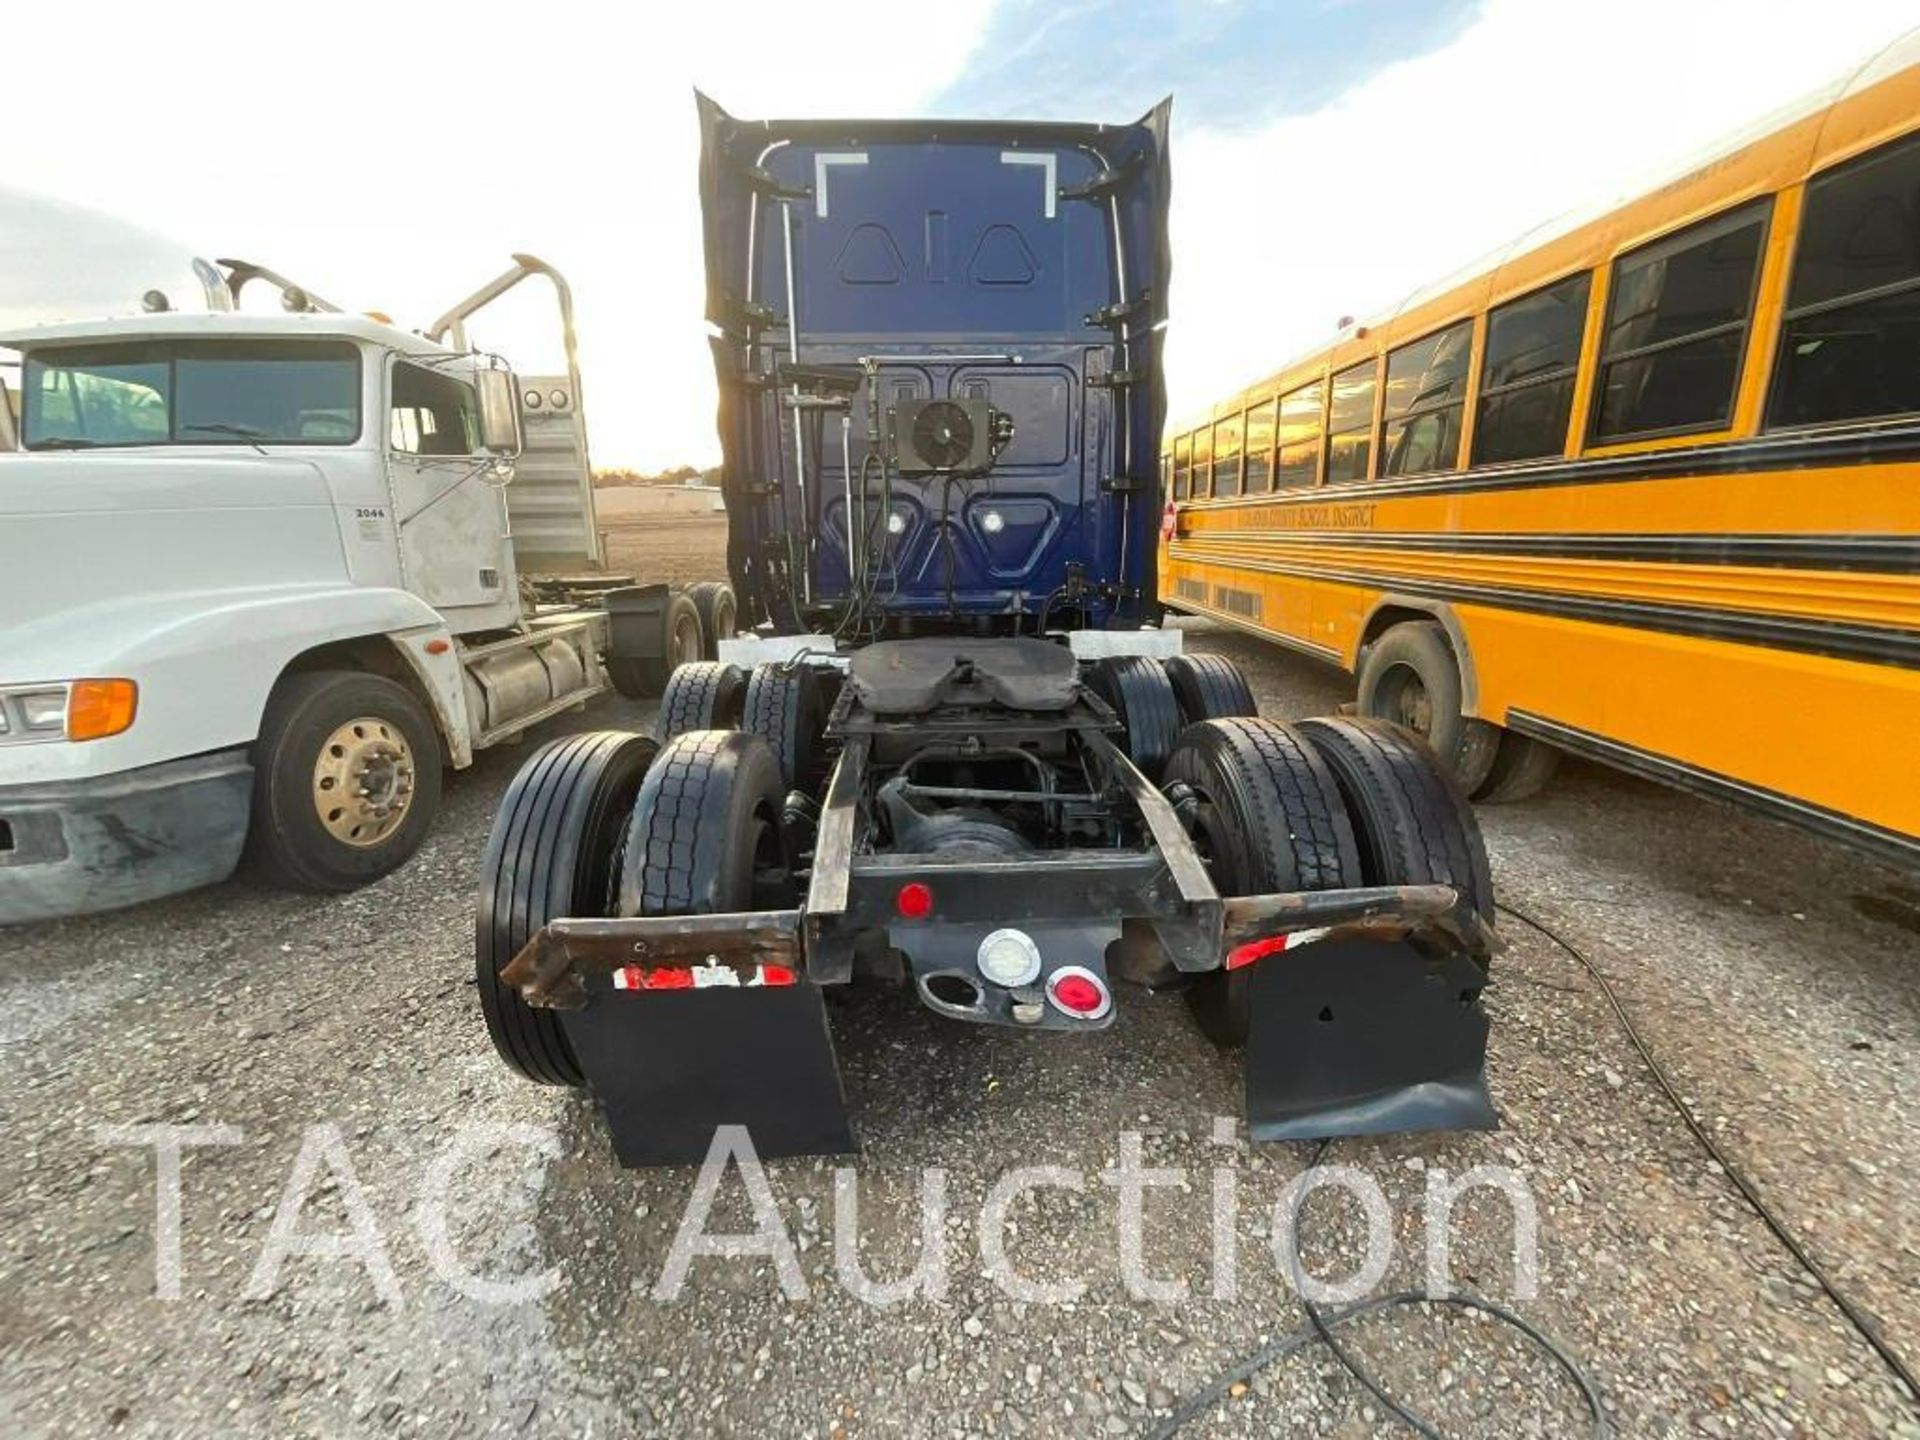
699, 96, 1169, 630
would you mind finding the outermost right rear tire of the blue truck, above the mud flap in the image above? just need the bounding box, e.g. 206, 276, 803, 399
1298, 718, 1494, 924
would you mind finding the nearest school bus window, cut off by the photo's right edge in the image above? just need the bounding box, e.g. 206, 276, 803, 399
1768, 136, 1920, 424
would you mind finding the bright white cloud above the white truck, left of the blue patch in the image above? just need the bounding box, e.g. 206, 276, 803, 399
0, 0, 989, 467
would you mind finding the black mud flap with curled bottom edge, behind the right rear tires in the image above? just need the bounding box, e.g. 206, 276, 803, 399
1246, 937, 1500, 1140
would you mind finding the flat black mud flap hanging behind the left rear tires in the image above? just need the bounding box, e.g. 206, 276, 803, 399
563, 985, 856, 1167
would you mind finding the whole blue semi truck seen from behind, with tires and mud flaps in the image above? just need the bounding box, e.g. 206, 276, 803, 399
476, 96, 1496, 1165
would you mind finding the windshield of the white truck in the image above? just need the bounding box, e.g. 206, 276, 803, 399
21, 340, 361, 449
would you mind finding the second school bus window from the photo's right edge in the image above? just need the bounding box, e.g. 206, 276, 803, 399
1594, 202, 1770, 442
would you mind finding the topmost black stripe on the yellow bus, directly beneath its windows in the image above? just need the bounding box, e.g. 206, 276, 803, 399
1175, 424, 1920, 509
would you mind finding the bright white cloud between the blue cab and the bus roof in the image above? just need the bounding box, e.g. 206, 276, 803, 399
1167, 0, 1914, 426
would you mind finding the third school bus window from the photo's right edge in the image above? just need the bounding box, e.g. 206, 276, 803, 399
1473, 271, 1594, 465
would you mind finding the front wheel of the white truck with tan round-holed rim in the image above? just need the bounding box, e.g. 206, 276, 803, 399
246, 670, 440, 893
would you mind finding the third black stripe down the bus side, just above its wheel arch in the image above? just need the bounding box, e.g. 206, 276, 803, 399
1167, 561, 1920, 670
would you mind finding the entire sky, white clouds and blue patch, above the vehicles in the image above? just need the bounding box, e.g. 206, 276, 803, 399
0, 0, 1914, 468
